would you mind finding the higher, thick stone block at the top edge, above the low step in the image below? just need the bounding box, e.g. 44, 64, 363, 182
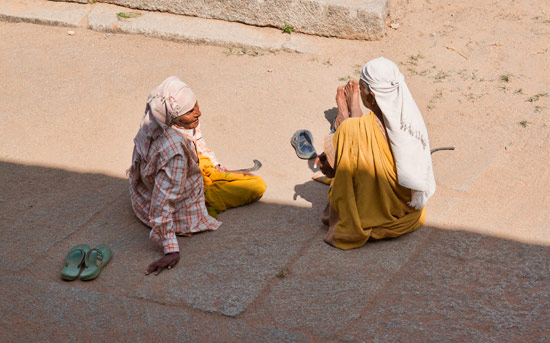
53, 0, 390, 40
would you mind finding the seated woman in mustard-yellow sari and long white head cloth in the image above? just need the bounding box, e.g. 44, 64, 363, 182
319, 57, 435, 250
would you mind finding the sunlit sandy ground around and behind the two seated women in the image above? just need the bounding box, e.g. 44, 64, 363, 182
0, 1, 550, 240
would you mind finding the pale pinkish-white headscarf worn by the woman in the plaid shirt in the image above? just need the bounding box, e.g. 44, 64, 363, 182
128, 76, 197, 181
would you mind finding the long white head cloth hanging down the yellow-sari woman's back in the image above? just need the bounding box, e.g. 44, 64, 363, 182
361, 57, 435, 209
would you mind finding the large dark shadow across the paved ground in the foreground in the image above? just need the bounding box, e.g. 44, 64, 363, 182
0, 162, 550, 342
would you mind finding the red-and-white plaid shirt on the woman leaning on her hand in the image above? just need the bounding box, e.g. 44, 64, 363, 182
130, 128, 221, 254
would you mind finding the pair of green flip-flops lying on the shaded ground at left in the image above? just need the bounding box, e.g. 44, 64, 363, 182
61, 244, 113, 281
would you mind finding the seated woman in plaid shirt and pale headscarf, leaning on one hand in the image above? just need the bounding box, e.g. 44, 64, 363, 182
128, 76, 266, 275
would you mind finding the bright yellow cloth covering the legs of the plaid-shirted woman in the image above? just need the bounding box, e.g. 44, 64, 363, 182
199, 155, 266, 214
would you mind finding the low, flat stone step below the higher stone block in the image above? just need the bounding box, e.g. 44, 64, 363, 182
0, 0, 328, 54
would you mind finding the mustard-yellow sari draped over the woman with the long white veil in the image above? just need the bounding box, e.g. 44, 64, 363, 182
324, 112, 425, 250
